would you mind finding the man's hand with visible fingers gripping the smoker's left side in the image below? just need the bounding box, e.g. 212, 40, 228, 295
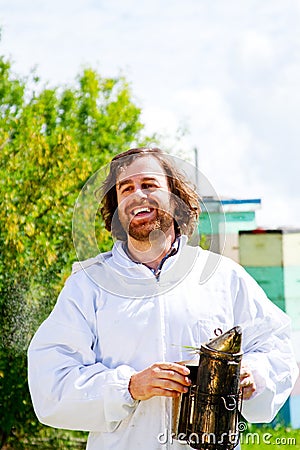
128, 362, 191, 400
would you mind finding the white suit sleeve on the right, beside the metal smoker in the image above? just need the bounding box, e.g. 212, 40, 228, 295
235, 268, 298, 423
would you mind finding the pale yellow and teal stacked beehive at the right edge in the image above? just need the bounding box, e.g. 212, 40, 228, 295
239, 229, 300, 428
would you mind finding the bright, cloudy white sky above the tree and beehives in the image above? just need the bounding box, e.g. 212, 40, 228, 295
0, 0, 300, 228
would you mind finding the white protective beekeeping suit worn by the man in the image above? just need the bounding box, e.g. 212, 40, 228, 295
28, 237, 298, 450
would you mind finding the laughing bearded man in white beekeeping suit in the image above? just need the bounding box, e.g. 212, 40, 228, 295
28, 148, 297, 450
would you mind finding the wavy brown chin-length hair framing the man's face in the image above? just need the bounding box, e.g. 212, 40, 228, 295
97, 147, 201, 241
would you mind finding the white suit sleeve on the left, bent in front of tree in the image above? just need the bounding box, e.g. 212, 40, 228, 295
28, 274, 138, 432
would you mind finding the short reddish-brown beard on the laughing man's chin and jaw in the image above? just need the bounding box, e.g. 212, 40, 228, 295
127, 210, 174, 241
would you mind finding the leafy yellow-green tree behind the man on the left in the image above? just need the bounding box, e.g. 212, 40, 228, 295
0, 57, 152, 448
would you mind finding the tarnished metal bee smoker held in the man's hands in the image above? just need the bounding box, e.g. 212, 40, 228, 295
173, 327, 242, 450
